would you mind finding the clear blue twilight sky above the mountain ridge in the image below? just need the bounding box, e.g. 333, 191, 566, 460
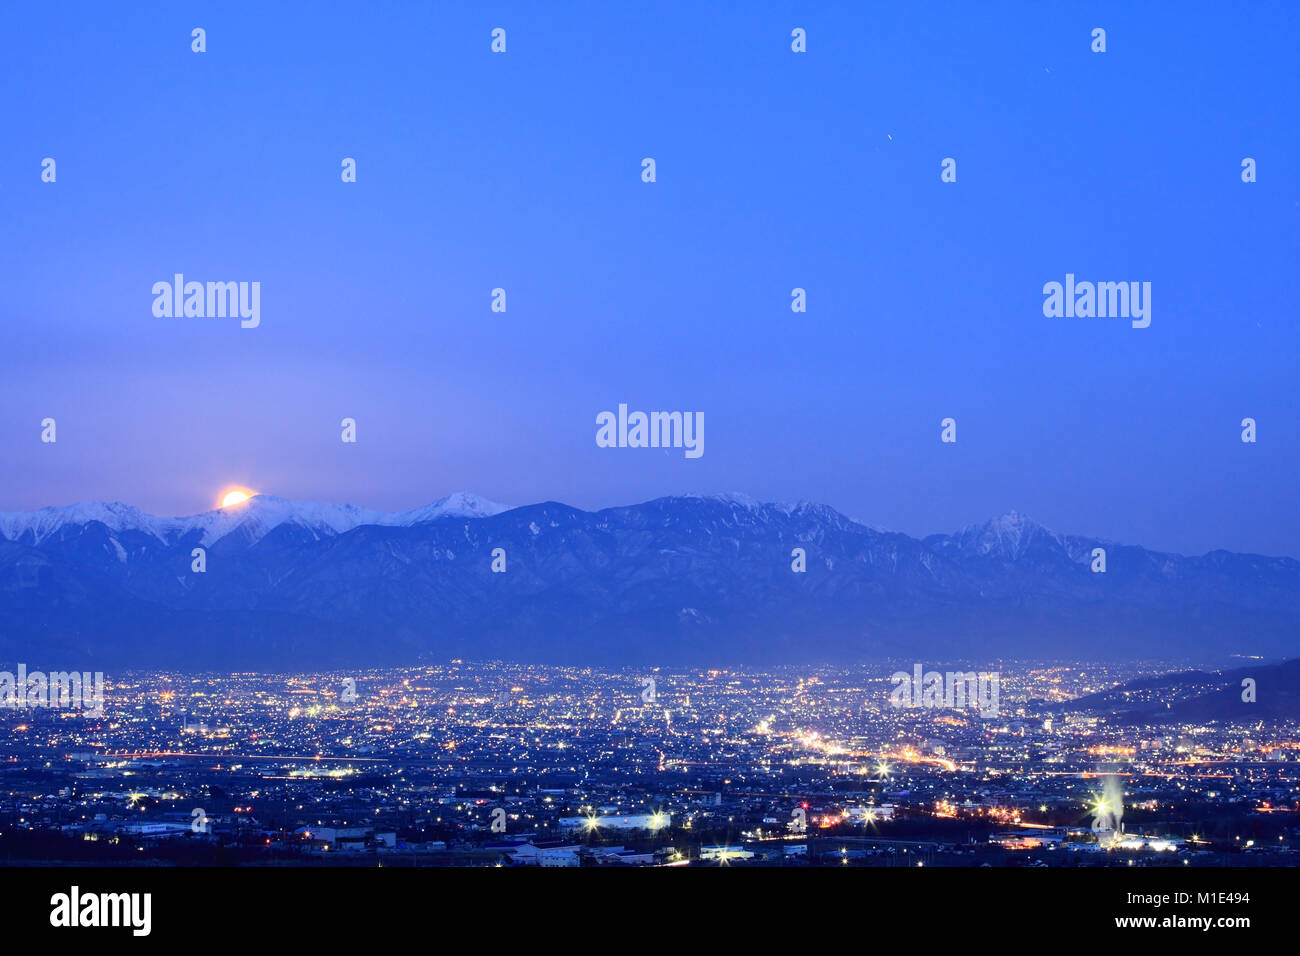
0, 3, 1300, 554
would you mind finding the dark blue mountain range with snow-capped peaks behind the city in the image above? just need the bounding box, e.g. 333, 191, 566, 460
0, 494, 1300, 670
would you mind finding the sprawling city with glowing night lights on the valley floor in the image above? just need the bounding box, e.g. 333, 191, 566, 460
0, 661, 1300, 866
